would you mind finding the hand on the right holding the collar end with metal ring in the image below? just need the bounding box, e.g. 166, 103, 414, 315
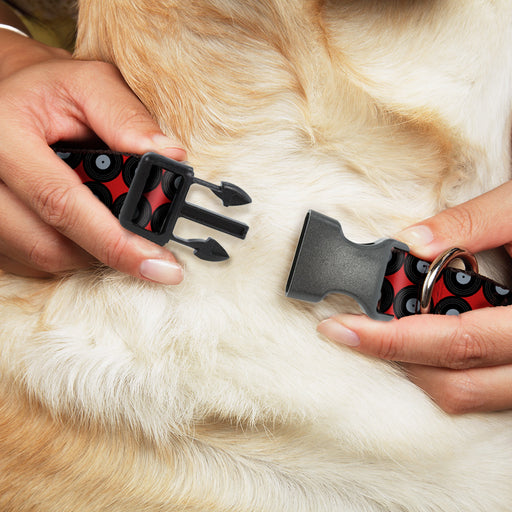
318, 182, 512, 414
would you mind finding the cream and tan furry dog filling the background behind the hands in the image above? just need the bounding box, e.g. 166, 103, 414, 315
0, 0, 512, 512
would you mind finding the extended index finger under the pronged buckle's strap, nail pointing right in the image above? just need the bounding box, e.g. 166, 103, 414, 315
1, 137, 183, 284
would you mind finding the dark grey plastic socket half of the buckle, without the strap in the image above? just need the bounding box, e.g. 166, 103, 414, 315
286, 210, 409, 320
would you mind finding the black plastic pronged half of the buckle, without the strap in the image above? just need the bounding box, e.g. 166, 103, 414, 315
119, 153, 251, 261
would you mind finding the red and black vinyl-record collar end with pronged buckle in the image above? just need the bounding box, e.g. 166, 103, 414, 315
53, 147, 251, 261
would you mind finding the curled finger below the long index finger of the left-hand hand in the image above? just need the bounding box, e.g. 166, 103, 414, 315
0, 184, 93, 275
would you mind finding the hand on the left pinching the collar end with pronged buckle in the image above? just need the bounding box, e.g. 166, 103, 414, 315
0, 30, 186, 284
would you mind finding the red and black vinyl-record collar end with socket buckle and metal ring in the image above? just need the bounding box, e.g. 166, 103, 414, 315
286, 210, 512, 320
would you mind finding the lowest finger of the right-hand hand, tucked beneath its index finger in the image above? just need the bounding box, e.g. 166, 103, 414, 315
404, 365, 512, 414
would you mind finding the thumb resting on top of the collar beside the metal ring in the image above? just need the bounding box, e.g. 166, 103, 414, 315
395, 182, 512, 260
